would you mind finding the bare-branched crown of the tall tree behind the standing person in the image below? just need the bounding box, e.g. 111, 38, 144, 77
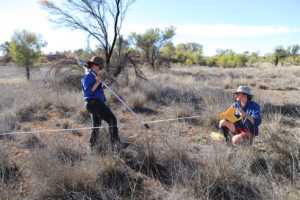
40, 0, 135, 67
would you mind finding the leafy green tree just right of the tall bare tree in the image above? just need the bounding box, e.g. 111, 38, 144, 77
129, 26, 175, 69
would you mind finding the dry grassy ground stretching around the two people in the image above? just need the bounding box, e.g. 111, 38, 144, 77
0, 64, 300, 199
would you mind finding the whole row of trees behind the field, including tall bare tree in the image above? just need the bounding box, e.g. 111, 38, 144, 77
0, 0, 300, 79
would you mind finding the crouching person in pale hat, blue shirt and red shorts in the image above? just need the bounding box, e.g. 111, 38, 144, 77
219, 86, 261, 145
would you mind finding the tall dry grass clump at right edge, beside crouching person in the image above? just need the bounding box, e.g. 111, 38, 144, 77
255, 113, 300, 183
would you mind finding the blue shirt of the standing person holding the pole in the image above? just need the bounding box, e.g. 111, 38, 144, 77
81, 71, 106, 102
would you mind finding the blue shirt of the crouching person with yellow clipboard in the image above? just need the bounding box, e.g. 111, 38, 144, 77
231, 101, 261, 136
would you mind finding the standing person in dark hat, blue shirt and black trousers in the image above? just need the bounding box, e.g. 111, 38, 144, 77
81, 56, 128, 148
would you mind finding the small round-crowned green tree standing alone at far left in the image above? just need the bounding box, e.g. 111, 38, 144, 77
9, 30, 47, 80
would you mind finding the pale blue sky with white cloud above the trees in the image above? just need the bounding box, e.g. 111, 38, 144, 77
0, 0, 300, 56
